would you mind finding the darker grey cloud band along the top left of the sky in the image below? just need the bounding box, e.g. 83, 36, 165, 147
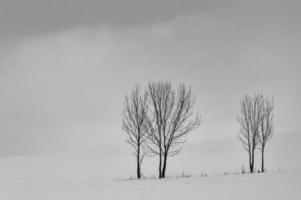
0, 0, 225, 36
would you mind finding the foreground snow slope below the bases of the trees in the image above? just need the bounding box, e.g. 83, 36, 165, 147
0, 172, 301, 200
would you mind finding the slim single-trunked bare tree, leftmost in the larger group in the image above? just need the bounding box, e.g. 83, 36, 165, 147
122, 85, 148, 179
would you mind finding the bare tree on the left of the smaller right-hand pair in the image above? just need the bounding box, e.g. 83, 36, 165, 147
237, 94, 263, 173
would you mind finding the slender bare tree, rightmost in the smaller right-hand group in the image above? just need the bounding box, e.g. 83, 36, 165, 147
259, 98, 274, 172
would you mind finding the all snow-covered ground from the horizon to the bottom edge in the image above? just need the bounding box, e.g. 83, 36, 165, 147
0, 132, 301, 200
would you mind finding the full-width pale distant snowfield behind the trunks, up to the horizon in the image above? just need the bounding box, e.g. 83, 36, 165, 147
0, 131, 301, 179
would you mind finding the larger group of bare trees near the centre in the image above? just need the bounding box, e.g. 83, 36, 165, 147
122, 81, 201, 179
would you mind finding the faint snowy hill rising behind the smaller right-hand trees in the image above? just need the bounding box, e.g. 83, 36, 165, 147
178, 131, 301, 172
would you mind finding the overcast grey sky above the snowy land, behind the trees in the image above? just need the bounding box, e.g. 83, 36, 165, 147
0, 0, 301, 155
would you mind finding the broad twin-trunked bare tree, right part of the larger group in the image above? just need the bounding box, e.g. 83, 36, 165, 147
147, 82, 200, 178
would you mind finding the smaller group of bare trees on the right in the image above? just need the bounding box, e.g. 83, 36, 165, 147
238, 94, 274, 173
